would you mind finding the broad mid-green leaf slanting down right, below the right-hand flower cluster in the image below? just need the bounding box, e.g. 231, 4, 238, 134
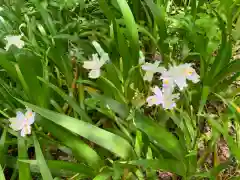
135, 112, 186, 160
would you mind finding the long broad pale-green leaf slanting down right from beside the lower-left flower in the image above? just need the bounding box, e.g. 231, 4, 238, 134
18, 100, 134, 159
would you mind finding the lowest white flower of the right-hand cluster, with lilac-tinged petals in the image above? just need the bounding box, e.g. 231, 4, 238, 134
147, 86, 179, 109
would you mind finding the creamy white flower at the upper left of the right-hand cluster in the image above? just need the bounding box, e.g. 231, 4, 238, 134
142, 61, 165, 82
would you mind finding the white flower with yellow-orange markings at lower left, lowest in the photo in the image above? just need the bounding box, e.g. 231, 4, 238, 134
9, 109, 35, 137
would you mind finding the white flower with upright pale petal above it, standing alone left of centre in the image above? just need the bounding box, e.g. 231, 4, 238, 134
83, 41, 110, 79
